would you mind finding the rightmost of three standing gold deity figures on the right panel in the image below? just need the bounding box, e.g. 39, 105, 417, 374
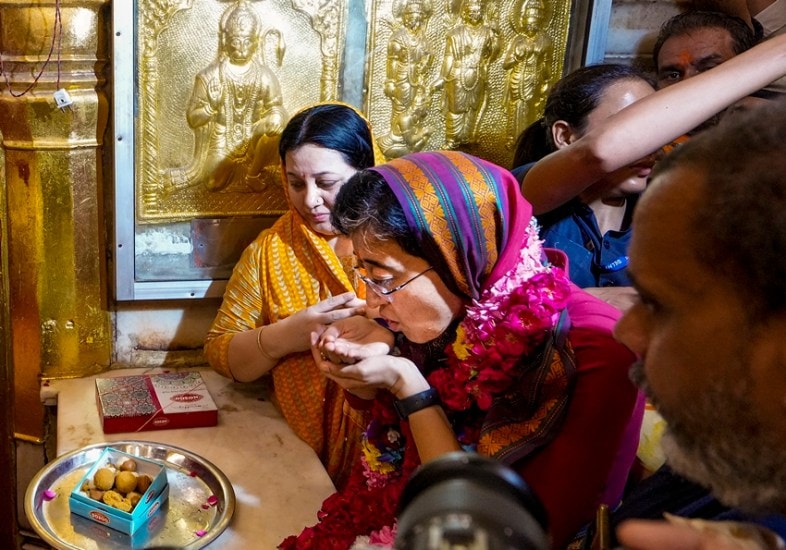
502, 0, 553, 148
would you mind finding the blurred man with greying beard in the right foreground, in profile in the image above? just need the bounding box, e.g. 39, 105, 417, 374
616, 102, 786, 549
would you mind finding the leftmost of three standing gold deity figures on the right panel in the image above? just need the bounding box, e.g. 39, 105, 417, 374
379, 0, 434, 158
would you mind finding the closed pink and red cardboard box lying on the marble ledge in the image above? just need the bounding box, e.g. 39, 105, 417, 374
96, 372, 218, 433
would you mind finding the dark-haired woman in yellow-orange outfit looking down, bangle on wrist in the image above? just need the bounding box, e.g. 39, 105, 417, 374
205, 103, 384, 492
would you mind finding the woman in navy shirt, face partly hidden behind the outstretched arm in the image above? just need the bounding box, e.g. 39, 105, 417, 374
513, 65, 655, 287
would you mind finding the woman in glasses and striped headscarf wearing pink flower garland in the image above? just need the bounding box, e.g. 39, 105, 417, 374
284, 152, 643, 548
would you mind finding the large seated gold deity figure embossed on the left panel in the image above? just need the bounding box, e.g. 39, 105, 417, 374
168, 0, 287, 191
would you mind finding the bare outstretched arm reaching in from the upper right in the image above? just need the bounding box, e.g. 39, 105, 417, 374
521, 31, 786, 214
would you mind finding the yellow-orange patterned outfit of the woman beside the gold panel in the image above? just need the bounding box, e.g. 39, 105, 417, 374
205, 101, 382, 486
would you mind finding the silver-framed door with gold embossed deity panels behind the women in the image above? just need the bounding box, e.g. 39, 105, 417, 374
109, 0, 611, 301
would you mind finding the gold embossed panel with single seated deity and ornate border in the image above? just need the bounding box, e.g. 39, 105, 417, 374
135, 0, 346, 223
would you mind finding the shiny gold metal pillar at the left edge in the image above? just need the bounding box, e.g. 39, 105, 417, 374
0, 0, 112, 437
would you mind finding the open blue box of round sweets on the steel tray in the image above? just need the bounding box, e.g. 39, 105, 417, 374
68, 447, 169, 535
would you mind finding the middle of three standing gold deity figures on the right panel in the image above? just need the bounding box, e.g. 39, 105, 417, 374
440, 0, 499, 149
